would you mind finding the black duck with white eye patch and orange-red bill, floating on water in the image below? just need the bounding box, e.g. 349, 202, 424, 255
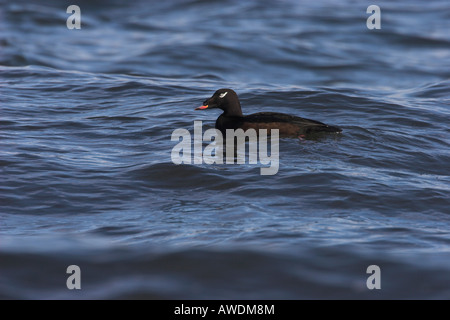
195, 89, 342, 137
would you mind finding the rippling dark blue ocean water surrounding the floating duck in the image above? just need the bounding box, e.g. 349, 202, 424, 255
0, 0, 450, 299
